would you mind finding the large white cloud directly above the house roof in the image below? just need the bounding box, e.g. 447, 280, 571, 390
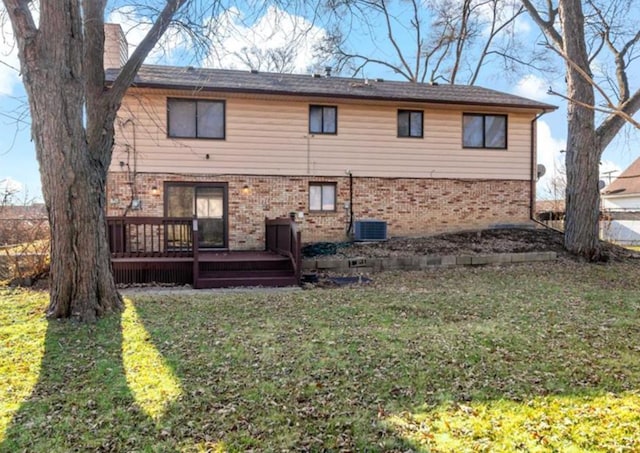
205, 7, 326, 73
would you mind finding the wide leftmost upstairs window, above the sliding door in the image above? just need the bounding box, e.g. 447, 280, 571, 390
167, 99, 225, 139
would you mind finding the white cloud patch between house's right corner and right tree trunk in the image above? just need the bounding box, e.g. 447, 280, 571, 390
536, 120, 567, 199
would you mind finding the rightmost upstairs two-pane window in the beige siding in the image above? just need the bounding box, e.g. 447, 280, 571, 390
462, 113, 507, 149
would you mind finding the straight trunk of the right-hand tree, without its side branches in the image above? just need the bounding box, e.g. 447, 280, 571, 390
560, 0, 601, 261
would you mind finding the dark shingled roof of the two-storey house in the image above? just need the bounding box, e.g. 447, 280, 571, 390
106, 65, 557, 111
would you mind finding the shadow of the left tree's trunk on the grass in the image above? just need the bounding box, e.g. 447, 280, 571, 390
0, 306, 162, 451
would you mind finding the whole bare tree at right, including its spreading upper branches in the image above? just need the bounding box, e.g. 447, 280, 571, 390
522, 0, 640, 260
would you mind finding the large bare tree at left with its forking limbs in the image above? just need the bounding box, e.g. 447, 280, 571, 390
2, 0, 194, 321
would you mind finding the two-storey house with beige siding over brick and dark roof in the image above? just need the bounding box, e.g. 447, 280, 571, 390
105, 24, 555, 284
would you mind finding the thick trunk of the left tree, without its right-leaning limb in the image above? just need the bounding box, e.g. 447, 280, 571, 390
23, 2, 122, 322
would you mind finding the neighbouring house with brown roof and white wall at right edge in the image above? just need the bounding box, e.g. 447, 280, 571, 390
601, 158, 640, 245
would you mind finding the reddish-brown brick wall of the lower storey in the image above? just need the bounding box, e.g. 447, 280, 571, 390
107, 172, 530, 250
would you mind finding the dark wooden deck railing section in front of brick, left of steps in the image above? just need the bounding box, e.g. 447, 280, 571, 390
107, 217, 195, 258
